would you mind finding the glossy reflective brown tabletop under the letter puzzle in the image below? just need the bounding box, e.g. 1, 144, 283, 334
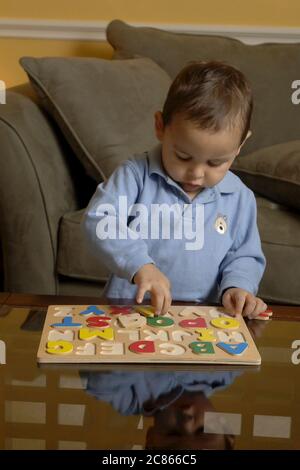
0, 306, 300, 450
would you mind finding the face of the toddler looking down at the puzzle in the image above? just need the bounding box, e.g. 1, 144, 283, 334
155, 111, 251, 194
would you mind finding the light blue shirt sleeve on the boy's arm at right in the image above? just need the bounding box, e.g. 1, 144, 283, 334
218, 188, 266, 301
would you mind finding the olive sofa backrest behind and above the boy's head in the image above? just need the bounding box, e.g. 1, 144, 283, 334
107, 20, 300, 155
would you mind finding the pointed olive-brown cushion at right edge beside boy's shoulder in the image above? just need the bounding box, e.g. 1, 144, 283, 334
231, 140, 300, 210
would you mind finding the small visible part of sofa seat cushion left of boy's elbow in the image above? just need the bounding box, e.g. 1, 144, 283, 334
56, 210, 109, 282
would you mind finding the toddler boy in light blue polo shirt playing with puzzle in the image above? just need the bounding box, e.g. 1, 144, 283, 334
82, 61, 267, 318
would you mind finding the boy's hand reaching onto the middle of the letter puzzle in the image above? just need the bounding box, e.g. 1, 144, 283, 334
133, 264, 172, 315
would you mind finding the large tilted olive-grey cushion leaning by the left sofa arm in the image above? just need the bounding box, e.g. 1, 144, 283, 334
20, 57, 170, 182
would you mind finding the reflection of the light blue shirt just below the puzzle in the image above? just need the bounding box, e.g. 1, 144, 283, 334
81, 370, 242, 415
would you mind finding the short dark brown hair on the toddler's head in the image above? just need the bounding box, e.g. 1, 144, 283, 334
162, 61, 253, 143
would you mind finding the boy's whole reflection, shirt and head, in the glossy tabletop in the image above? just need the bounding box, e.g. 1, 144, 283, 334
82, 371, 241, 449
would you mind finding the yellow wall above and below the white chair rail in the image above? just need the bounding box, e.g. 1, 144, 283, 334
0, 0, 300, 87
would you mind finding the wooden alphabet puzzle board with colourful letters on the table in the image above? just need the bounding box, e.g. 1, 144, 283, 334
38, 305, 261, 364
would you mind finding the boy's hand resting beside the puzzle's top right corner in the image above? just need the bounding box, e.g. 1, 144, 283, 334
222, 287, 268, 318
